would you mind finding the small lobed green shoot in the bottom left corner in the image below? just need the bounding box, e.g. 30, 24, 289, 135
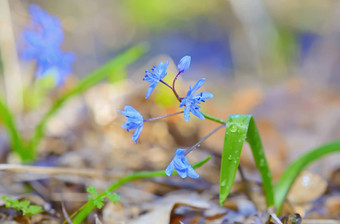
1, 195, 43, 217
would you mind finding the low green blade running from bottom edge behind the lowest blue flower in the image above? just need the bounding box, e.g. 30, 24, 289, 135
70, 156, 211, 224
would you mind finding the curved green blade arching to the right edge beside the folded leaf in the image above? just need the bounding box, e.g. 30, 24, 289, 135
274, 141, 340, 215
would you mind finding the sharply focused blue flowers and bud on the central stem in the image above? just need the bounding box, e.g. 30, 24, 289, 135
119, 56, 213, 178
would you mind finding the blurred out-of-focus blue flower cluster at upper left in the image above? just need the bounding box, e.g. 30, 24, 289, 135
21, 5, 75, 86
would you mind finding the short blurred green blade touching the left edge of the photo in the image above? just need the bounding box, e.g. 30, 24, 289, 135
0, 98, 27, 160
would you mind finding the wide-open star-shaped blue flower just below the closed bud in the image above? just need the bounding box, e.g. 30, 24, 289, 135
179, 78, 213, 122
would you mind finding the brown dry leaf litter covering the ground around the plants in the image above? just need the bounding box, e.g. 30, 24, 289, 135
0, 76, 340, 224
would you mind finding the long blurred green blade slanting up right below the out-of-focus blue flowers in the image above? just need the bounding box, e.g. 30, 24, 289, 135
29, 45, 147, 155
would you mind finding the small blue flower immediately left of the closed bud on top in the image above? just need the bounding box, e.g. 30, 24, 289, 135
143, 61, 169, 99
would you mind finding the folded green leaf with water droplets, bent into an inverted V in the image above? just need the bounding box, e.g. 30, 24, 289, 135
219, 115, 274, 206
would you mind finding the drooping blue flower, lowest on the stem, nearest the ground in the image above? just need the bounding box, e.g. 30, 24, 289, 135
165, 149, 199, 179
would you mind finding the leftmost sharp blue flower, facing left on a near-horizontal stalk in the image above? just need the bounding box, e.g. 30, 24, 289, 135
119, 106, 144, 143
